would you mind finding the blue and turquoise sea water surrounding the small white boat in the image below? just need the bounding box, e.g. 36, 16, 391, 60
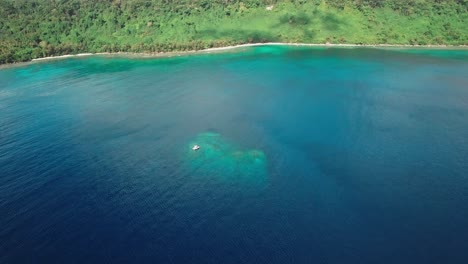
0, 47, 468, 263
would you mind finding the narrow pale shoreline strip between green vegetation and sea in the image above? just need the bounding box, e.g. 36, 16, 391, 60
0, 42, 468, 69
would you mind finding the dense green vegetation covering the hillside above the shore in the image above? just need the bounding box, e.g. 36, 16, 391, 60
0, 0, 468, 63
